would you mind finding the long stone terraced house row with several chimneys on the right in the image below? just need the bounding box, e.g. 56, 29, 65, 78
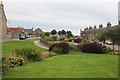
80, 22, 120, 40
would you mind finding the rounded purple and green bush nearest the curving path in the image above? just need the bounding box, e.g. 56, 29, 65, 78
49, 42, 69, 54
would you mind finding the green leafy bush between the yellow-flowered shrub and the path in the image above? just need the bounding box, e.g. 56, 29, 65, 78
14, 47, 41, 61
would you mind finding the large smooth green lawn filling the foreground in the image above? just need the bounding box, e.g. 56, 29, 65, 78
3, 51, 118, 78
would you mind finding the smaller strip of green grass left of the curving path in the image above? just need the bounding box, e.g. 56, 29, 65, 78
2, 39, 45, 56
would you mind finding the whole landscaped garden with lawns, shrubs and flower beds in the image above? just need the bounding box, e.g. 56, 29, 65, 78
2, 30, 120, 78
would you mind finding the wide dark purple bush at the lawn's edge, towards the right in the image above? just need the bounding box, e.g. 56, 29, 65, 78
78, 43, 102, 54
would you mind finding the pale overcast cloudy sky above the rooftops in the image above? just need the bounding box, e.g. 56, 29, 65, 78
3, 0, 119, 35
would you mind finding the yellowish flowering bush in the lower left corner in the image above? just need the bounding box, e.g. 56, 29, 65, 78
2, 56, 25, 73
